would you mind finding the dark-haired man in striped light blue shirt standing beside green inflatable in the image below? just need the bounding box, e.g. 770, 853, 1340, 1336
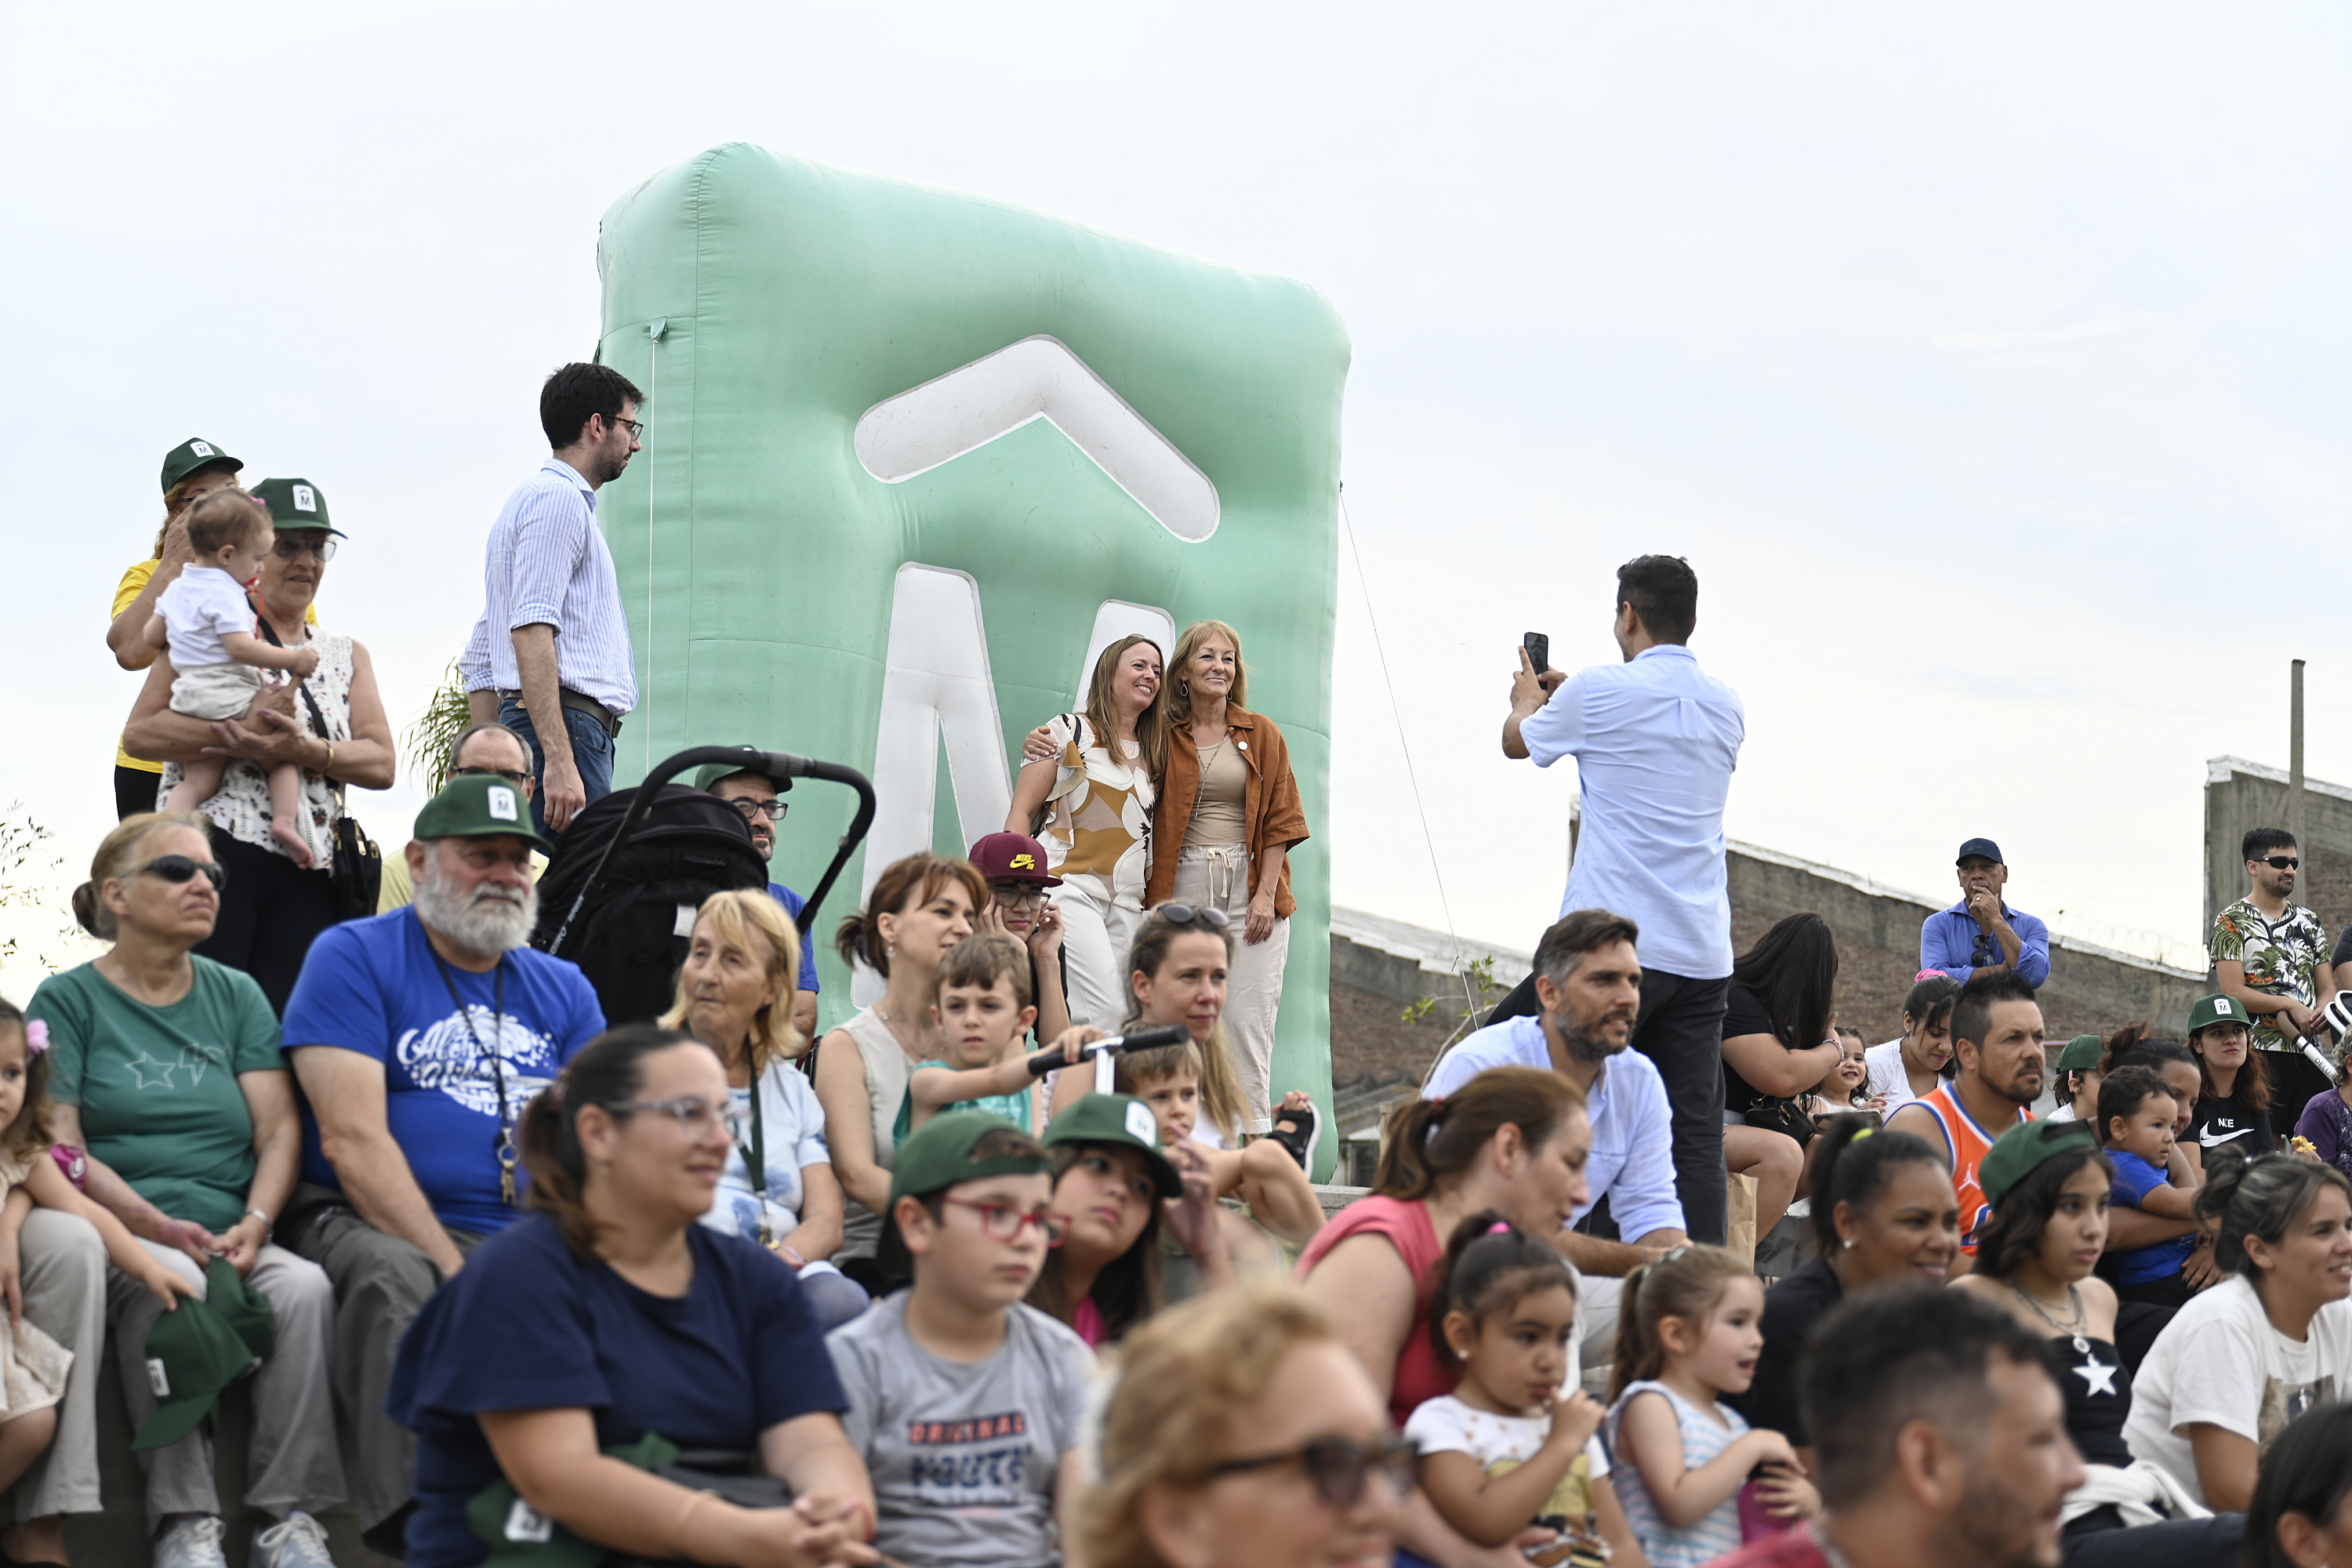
459, 365, 644, 832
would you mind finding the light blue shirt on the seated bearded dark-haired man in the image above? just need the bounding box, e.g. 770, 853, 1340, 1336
1421, 1015, 1684, 1241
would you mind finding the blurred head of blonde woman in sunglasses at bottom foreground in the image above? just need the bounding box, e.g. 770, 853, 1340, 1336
1077, 1286, 1411, 1568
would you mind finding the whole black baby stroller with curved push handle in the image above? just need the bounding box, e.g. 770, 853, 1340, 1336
532, 746, 875, 1025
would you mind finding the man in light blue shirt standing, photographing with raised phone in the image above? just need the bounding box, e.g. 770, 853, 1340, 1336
1489, 555, 1748, 1243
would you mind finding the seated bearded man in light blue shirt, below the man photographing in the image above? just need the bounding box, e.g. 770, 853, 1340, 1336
1421, 909, 1689, 1361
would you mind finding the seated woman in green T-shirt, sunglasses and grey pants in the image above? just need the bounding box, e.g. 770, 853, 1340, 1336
26, 811, 346, 1566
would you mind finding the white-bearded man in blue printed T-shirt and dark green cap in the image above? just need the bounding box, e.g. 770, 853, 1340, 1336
278, 774, 604, 1556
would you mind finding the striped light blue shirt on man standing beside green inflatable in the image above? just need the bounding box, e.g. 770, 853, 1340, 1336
459, 459, 637, 715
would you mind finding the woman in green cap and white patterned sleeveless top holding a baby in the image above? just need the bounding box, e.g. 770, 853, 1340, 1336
122, 480, 393, 1015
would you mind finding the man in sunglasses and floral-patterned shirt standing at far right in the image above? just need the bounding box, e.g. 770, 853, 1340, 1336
2211, 827, 2336, 1121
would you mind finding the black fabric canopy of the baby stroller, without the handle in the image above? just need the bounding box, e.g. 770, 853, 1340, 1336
532, 785, 767, 1025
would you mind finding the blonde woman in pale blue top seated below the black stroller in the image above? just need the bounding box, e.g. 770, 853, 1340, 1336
661, 888, 870, 1330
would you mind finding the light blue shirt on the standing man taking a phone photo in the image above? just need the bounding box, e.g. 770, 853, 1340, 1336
1519, 642, 1748, 973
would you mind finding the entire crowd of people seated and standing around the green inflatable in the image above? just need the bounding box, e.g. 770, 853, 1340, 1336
23, 365, 2352, 1568
